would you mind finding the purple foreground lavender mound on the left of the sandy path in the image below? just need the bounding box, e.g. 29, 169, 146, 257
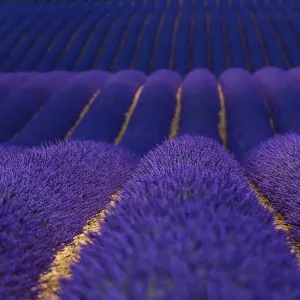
0, 141, 136, 299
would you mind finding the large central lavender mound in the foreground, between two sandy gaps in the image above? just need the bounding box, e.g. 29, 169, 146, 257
60, 136, 300, 300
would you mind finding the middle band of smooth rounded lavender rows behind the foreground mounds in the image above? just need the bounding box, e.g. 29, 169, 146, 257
0, 67, 300, 159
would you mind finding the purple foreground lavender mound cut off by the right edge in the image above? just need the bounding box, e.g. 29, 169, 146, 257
244, 133, 300, 250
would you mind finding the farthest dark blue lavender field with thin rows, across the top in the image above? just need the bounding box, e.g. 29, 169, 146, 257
0, 0, 300, 76
